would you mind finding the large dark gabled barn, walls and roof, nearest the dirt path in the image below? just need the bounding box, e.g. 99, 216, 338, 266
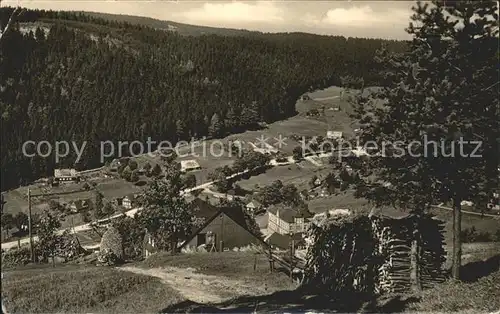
178, 198, 267, 252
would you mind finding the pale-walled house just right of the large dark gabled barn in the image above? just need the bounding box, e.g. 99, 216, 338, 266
267, 205, 313, 234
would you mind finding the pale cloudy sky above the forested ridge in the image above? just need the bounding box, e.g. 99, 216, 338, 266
0, 0, 415, 39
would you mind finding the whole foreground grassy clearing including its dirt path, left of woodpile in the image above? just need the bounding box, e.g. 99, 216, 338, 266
2, 251, 296, 313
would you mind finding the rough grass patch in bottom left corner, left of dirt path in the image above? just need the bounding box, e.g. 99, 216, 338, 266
2, 266, 183, 313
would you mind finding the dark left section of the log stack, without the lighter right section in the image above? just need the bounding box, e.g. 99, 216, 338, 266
303, 211, 375, 293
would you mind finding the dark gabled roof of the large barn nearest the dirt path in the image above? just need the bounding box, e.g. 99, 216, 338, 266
177, 198, 268, 250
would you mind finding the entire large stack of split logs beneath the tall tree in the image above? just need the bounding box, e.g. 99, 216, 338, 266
304, 210, 446, 294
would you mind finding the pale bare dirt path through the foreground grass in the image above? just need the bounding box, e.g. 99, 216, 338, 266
117, 266, 264, 304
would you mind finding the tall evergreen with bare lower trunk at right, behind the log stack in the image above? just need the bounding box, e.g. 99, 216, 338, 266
355, 1, 500, 279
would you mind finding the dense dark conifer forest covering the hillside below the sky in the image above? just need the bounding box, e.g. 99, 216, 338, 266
0, 8, 406, 190
